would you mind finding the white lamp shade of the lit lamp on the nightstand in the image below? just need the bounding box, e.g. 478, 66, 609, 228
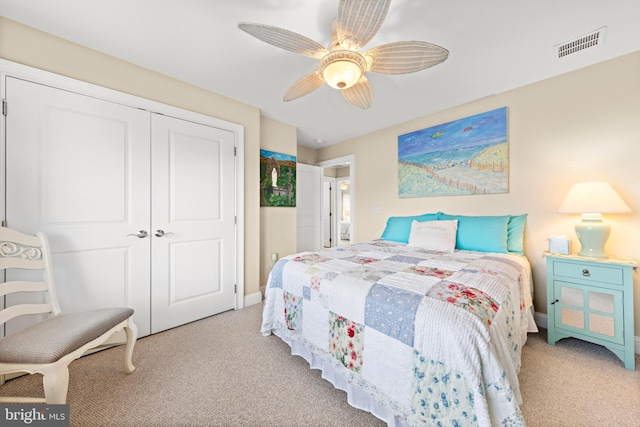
558, 181, 631, 214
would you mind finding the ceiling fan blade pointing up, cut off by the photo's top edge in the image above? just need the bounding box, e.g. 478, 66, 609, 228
337, 0, 391, 50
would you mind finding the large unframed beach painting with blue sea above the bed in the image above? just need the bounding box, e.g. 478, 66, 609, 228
398, 107, 509, 198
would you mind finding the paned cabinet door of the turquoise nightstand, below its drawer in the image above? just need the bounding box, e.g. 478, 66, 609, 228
553, 281, 624, 344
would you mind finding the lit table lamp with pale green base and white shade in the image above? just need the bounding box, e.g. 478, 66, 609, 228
558, 181, 631, 258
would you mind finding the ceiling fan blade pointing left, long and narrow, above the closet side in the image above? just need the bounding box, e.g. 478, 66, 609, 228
238, 22, 328, 58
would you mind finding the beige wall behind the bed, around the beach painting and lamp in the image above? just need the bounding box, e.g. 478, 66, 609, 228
318, 52, 640, 336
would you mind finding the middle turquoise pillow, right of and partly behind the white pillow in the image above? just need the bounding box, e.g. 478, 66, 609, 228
438, 213, 511, 254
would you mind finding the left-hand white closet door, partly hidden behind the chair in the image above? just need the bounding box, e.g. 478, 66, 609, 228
6, 77, 151, 336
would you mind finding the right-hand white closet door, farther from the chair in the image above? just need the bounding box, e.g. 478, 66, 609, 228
151, 114, 236, 333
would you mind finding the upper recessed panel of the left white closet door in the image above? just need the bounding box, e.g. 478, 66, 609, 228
41, 106, 130, 225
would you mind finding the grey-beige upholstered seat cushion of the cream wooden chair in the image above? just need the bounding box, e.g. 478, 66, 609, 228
0, 307, 133, 364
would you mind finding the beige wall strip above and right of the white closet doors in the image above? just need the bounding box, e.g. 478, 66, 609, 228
0, 17, 264, 295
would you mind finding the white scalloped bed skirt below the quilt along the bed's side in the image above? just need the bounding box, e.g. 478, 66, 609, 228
273, 331, 408, 427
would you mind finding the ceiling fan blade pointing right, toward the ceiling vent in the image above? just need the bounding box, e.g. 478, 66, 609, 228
363, 41, 449, 74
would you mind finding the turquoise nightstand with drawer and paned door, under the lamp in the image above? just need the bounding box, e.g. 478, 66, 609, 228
544, 252, 638, 371
